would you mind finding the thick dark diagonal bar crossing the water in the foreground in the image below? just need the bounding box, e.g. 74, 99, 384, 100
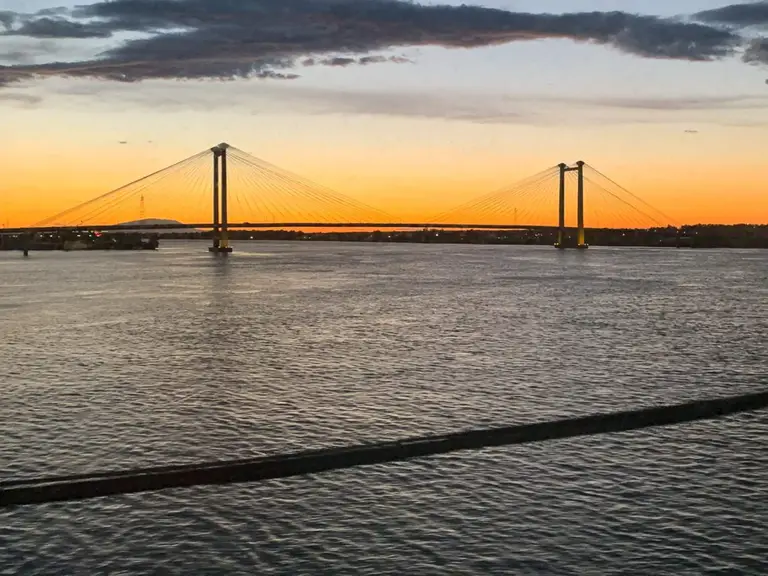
0, 390, 768, 508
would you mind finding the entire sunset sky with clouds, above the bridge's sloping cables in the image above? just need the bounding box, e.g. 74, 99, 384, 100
0, 0, 768, 226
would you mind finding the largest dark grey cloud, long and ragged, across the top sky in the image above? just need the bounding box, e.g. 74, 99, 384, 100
0, 0, 742, 83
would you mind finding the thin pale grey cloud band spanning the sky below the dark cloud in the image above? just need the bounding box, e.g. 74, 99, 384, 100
10, 74, 768, 130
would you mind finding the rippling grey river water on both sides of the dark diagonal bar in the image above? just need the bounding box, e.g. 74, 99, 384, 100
0, 242, 768, 575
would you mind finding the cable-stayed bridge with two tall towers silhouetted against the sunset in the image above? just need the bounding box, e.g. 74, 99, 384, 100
2, 144, 673, 252
